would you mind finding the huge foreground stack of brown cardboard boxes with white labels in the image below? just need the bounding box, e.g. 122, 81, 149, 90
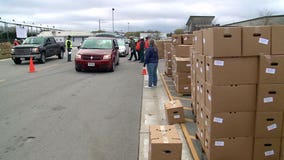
191, 27, 284, 160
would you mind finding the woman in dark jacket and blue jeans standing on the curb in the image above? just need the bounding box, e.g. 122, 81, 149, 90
144, 39, 159, 88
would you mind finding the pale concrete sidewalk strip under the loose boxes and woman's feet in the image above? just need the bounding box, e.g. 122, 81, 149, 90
139, 71, 193, 160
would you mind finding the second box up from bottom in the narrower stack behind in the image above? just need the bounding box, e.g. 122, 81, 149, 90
173, 57, 191, 73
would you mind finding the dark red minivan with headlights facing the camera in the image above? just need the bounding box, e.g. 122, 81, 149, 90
75, 37, 119, 72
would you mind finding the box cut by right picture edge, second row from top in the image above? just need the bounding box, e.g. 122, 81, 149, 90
259, 54, 284, 83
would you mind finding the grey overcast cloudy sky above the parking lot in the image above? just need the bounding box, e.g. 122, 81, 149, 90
0, 0, 284, 32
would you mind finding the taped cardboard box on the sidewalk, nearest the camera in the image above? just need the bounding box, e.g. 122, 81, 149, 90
149, 125, 182, 160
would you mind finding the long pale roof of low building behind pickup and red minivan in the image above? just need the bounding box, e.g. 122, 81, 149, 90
38, 30, 94, 37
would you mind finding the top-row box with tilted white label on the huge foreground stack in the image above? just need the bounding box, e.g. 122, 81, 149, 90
242, 26, 271, 56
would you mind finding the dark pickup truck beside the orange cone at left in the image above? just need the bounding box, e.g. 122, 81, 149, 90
11, 37, 65, 64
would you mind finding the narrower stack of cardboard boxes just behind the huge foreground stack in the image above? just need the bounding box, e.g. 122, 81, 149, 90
172, 34, 193, 94
